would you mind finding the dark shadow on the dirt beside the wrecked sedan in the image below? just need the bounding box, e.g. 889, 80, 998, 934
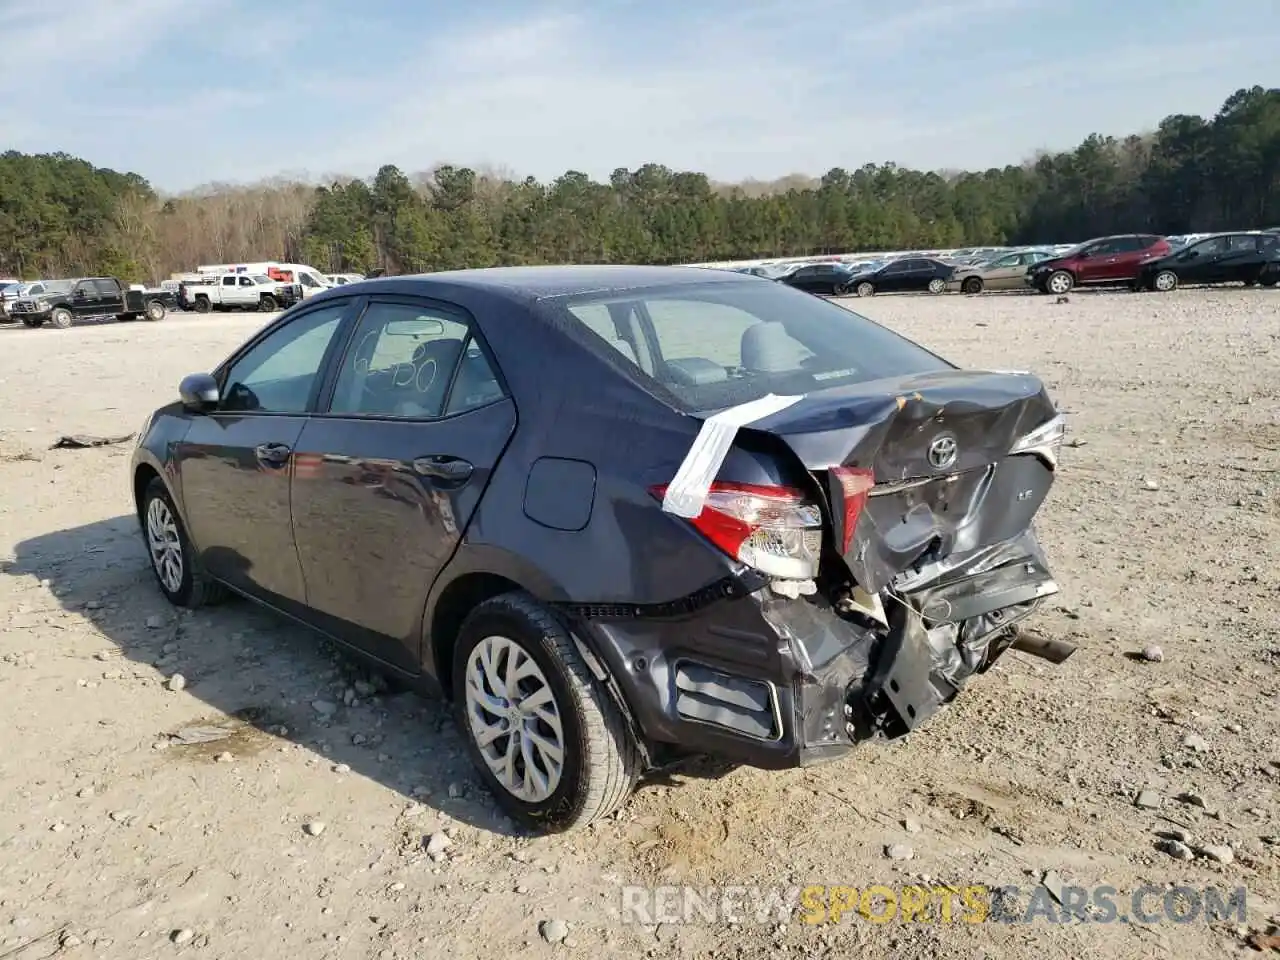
4, 516, 526, 836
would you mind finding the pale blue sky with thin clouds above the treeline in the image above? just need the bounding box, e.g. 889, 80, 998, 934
0, 0, 1280, 191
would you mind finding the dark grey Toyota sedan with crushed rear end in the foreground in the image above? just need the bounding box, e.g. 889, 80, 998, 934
129, 266, 1071, 832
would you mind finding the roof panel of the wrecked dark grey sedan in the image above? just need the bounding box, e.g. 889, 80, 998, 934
320, 265, 744, 301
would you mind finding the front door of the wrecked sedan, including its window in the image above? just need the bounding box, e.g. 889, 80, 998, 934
174, 298, 355, 613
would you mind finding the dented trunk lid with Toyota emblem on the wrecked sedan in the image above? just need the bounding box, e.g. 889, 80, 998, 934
751, 370, 1057, 594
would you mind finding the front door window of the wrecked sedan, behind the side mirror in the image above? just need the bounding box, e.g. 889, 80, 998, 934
219, 302, 347, 413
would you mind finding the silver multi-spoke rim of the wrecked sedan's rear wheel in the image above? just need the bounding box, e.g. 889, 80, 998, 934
466, 636, 564, 804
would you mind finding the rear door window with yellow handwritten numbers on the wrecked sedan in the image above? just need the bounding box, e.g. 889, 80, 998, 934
329, 301, 502, 420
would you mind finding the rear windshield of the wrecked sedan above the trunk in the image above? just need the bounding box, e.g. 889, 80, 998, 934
562, 280, 954, 413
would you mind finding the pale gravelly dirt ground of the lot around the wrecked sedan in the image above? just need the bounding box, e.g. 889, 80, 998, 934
0, 291, 1280, 960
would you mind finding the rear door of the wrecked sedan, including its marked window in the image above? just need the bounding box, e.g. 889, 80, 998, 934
292, 297, 516, 672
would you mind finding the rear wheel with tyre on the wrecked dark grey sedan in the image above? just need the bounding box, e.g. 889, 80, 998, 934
452, 593, 640, 833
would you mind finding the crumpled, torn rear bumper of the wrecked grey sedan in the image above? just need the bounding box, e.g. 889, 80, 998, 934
579, 532, 1070, 768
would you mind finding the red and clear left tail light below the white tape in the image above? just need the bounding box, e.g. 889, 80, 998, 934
650, 483, 822, 580
